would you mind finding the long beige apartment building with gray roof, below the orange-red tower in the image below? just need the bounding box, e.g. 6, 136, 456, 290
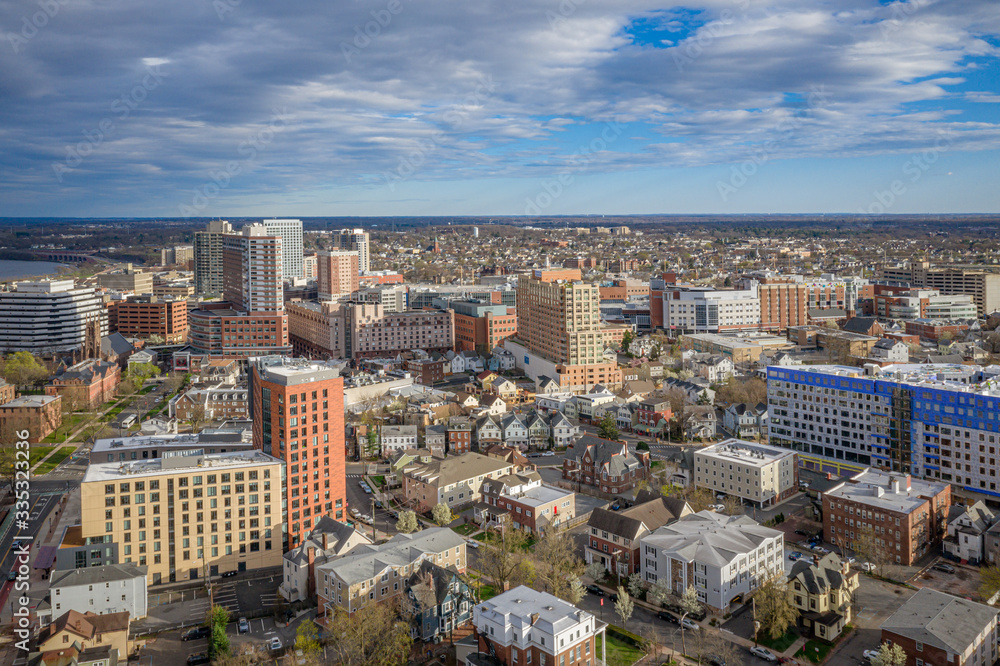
316, 527, 468, 618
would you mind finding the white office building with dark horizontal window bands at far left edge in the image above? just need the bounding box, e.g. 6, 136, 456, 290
0, 280, 108, 354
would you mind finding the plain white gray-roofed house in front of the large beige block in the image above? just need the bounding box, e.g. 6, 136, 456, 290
38, 562, 147, 625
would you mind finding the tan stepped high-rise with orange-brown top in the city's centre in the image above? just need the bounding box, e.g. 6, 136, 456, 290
515, 269, 621, 391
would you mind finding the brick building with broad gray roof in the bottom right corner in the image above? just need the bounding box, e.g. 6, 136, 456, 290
882, 587, 997, 666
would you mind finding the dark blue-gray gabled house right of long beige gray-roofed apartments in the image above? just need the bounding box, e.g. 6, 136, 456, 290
400, 560, 476, 643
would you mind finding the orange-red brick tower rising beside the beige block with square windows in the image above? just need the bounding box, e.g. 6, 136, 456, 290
249, 356, 347, 550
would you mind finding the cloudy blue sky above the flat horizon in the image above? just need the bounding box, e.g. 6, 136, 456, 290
0, 0, 1000, 217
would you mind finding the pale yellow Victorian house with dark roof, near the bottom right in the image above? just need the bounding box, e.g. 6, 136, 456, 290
788, 553, 860, 641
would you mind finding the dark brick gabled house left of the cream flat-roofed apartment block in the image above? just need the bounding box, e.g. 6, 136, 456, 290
563, 435, 650, 495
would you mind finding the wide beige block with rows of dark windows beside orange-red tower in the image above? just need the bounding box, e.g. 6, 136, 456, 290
80, 450, 284, 585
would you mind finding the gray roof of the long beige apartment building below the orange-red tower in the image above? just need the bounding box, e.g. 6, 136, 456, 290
320, 527, 465, 585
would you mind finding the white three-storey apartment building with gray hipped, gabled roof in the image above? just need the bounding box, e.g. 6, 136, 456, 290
639, 511, 785, 612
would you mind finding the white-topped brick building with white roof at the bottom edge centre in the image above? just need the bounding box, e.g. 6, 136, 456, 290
465, 585, 608, 666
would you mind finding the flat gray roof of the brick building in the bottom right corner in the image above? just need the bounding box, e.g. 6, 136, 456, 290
882, 587, 997, 654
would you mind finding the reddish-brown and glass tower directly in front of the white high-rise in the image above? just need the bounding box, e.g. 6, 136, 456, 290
222, 224, 285, 312
